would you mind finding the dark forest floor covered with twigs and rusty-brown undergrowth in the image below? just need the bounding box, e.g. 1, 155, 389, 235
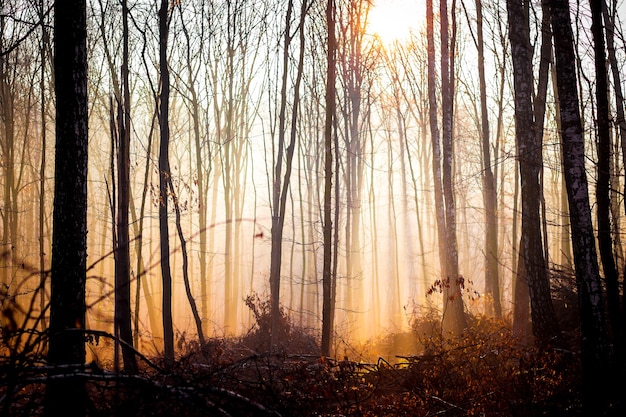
0, 302, 612, 417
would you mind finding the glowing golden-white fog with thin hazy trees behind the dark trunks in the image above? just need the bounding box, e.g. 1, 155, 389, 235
0, 0, 624, 376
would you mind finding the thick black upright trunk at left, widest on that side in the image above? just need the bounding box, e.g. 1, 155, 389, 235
45, 0, 88, 416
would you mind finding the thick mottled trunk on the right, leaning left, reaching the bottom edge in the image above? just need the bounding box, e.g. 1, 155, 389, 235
544, 0, 612, 415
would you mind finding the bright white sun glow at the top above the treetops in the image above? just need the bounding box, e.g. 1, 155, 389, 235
368, 0, 426, 44
